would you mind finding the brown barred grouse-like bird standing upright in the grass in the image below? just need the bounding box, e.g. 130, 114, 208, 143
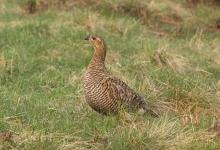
83, 35, 159, 117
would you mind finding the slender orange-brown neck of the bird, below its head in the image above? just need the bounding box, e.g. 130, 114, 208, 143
89, 47, 106, 70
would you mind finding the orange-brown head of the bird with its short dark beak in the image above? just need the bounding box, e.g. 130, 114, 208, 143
85, 35, 105, 50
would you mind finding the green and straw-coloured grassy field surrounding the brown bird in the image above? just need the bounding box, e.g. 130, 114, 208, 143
0, 0, 220, 150
